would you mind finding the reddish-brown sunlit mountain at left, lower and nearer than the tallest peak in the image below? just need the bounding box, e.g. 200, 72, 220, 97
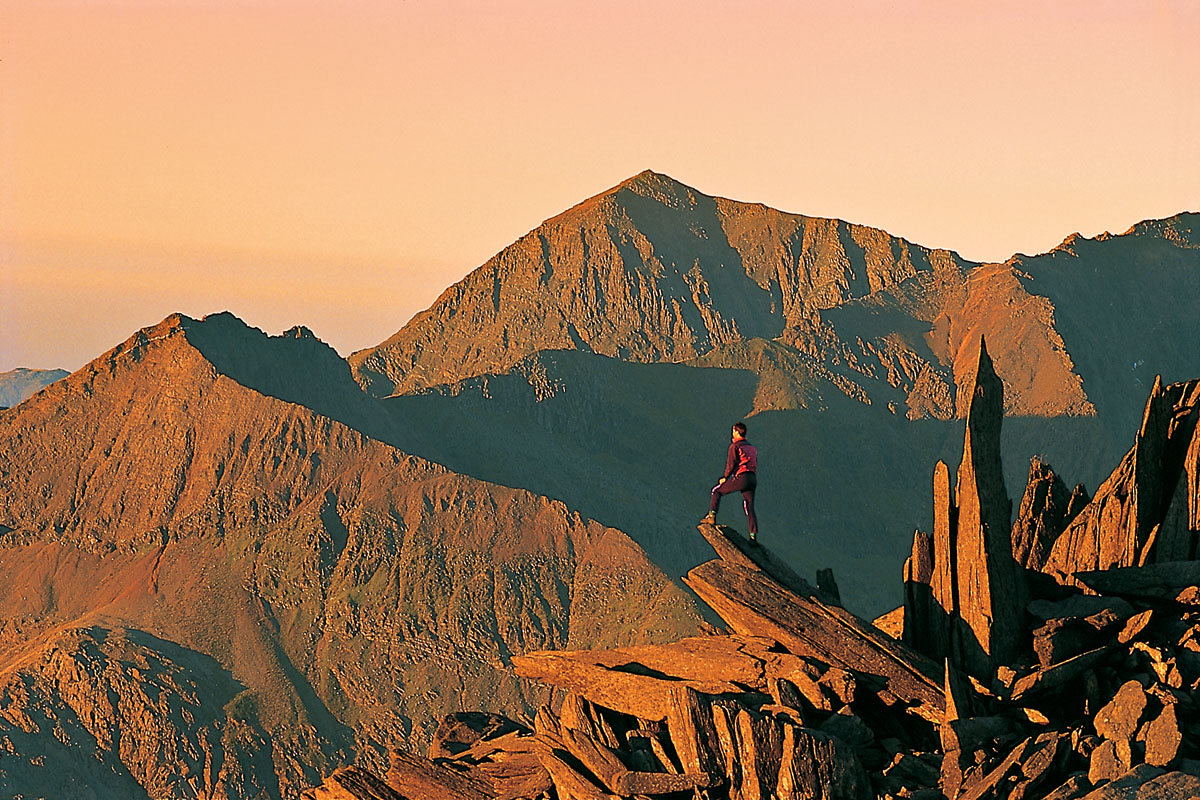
0, 315, 701, 798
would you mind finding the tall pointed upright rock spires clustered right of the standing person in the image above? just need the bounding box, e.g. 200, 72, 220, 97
905, 339, 1026, 675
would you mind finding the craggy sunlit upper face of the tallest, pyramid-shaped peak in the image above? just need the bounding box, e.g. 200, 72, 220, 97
349, 172, 971, 396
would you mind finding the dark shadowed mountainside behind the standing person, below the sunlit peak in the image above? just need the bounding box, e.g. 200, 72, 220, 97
384, 339, 1136, 616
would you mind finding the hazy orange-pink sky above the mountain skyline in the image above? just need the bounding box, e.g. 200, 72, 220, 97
0, 0, 1200, 371
